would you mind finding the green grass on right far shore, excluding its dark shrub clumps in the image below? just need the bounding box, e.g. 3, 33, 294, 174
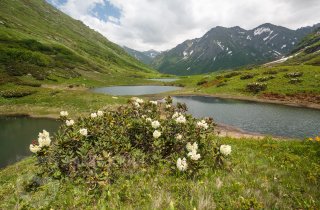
175, 65, 320, 97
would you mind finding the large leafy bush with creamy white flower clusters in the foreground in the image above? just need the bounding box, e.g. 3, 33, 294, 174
30, 97, 231, 186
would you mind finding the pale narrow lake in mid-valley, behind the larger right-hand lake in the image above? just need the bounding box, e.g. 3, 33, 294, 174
92, 85, 181, 96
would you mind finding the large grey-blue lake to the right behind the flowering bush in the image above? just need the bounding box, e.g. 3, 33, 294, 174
173, 96, 320, 138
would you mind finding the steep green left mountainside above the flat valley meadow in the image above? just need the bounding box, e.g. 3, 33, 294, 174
0, 0, 152, 83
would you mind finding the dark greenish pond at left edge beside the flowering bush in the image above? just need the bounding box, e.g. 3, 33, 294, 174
0, 117, 60, 168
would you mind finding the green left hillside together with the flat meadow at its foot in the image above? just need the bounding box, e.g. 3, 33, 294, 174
0, 0, 165, 115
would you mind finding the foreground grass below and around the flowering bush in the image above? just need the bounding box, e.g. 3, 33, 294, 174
0, 138, 320, 209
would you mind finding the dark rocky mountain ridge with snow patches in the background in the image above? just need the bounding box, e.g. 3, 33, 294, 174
152, 23, 320, 75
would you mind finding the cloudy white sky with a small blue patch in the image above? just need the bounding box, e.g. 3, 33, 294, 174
47, 0, 320, 51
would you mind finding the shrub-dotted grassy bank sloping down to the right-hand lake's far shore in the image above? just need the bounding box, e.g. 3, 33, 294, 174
173, 65, 320, 104
